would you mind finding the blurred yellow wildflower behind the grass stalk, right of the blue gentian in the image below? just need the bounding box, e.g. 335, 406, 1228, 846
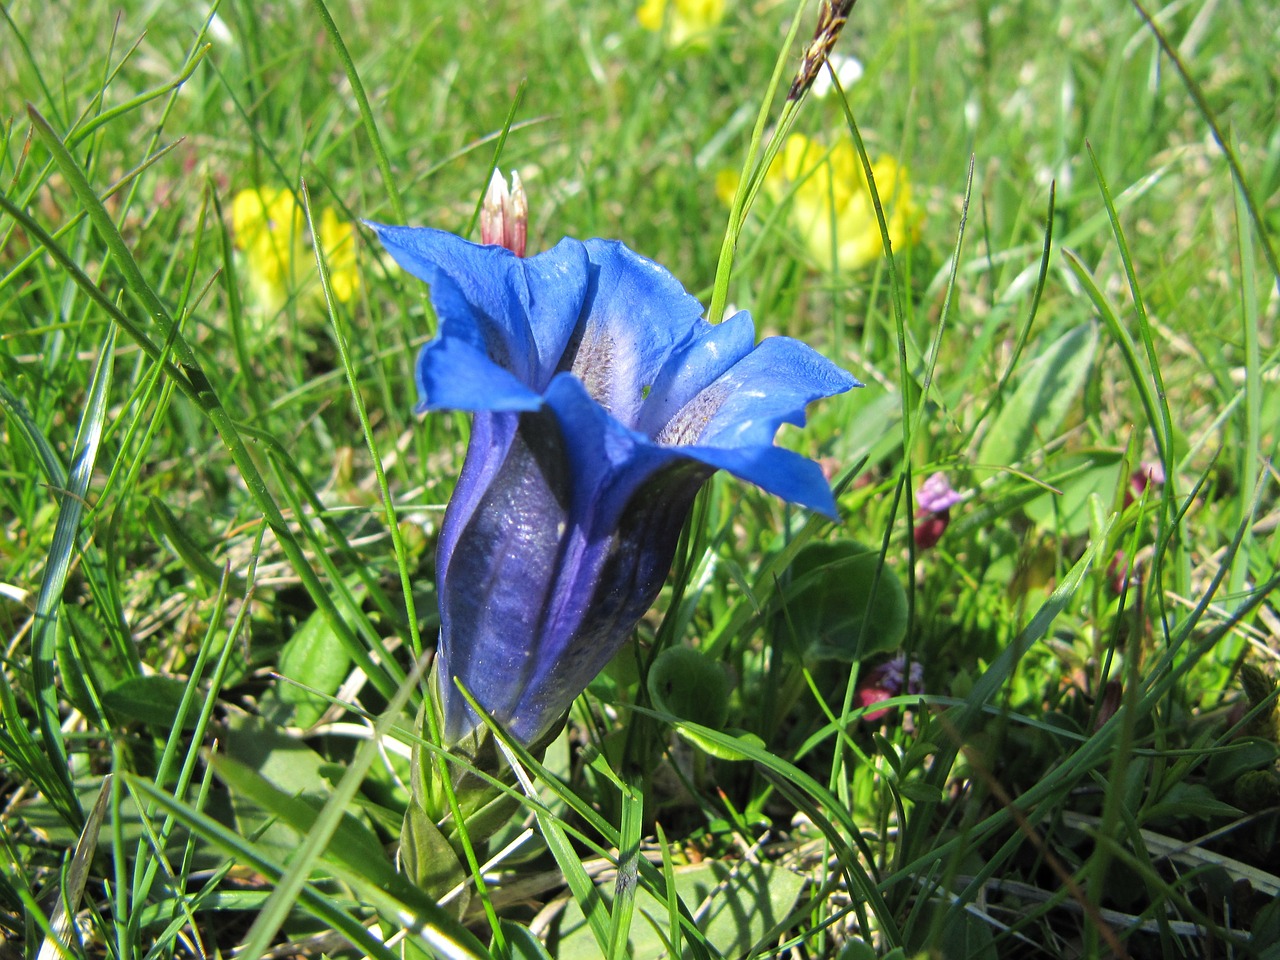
716, 133, 920, 270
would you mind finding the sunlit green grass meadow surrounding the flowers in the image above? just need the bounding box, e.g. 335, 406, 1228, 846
0, 0, 1280, 960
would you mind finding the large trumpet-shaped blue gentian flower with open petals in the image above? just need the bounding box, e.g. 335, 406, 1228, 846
370, 224, 856, 744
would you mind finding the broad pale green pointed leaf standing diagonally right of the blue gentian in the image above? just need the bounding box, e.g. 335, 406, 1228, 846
978, 323, 1098, 466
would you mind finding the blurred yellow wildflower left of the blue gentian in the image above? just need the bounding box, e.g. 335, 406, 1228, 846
232, 189, 360, 314
